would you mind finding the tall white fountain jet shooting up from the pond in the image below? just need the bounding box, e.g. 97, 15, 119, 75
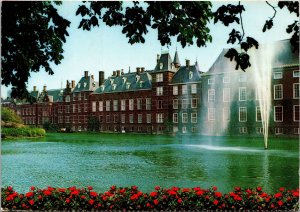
249, 45, 274, 149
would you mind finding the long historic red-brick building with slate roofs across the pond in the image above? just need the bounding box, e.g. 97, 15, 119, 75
3, 40, 300, 135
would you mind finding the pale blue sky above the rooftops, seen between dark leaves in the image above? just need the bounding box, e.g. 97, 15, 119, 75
1, 1, 297, 97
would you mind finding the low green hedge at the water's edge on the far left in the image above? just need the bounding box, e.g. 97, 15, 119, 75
1, 127, 46, 138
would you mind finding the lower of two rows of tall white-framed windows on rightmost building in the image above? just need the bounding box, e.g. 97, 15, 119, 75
207, 105, 300, 122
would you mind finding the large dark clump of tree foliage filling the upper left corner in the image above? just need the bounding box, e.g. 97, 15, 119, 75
1, 1, 70, 98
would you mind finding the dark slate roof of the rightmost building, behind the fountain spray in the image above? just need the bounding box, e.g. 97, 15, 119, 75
204, 39, 299, 75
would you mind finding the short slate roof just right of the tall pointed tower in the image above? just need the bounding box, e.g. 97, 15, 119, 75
171, 63, 202, 84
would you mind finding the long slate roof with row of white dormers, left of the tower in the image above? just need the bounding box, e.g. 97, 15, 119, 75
93, 72, 152, 94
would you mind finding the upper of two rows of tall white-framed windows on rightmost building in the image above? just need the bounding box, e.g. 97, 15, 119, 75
208, 83, 300, 102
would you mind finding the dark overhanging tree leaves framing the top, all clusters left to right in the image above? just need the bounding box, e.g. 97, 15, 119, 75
1, 1, 299, 97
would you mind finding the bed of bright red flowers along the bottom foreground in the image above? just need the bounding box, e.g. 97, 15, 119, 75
1, 186, 299, 211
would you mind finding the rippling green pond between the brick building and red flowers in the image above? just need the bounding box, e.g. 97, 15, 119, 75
1, 133, 299, 192
